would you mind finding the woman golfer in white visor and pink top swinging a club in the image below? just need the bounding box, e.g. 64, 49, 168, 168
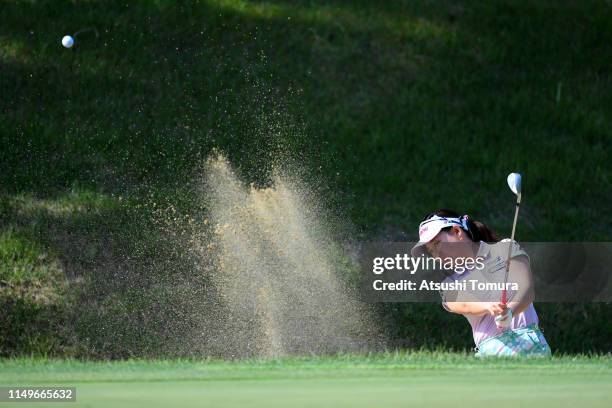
411, 209, 551, 357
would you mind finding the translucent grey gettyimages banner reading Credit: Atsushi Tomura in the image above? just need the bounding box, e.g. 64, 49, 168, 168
359, 241, 612, 303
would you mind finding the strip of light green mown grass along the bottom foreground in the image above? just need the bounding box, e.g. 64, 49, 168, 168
0, 353, 612, 408
